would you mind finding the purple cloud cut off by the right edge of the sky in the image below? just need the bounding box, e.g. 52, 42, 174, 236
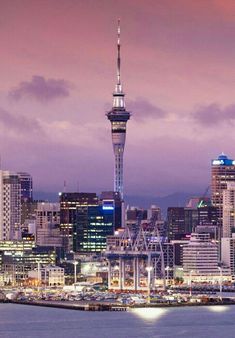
192, 103, 235, 127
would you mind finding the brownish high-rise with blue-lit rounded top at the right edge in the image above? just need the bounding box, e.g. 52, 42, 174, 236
211, 154, 235, 226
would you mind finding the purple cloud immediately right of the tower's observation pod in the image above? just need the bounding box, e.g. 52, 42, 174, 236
127, 97, 168, 120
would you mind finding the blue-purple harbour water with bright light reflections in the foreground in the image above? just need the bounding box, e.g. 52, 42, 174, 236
0, 304, 235, 338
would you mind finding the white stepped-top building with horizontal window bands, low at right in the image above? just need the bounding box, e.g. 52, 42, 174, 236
183, 233, 220, 282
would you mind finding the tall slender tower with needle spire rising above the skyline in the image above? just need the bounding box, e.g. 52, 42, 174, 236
106, 20, 131, 199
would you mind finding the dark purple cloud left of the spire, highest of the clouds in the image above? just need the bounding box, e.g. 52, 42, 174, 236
9, 75, 71, 102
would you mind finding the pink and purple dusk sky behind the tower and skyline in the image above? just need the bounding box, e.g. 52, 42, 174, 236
0, 0, 235, 195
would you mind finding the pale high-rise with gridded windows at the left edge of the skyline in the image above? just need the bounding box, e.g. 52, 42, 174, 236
0, 170, 21, 240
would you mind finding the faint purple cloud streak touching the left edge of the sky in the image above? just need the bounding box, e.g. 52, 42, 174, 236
0, 108, 43, 134
